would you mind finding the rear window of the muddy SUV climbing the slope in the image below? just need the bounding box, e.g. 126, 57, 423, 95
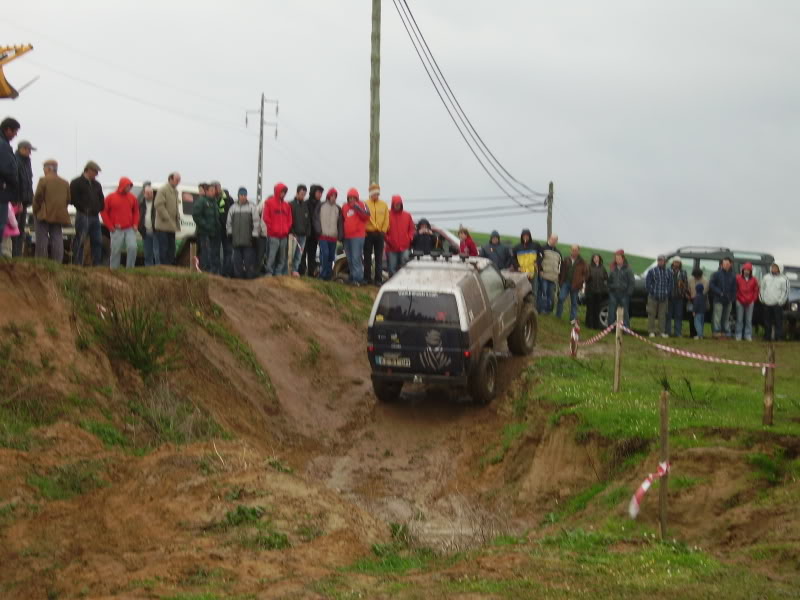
375, 291, 459, 325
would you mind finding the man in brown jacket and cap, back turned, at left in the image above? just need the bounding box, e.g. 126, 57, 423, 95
33, 158, 70, 263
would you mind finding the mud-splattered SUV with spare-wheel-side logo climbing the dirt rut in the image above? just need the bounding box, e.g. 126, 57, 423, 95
367, 256, 537, 403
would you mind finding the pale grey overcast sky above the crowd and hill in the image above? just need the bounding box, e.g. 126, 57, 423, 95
0, 0, 800, 264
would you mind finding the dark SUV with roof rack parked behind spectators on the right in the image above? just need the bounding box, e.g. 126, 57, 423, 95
600, 246, 775, 327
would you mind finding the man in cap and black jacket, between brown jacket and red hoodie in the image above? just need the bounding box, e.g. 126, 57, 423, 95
69, 160, 105, 267
